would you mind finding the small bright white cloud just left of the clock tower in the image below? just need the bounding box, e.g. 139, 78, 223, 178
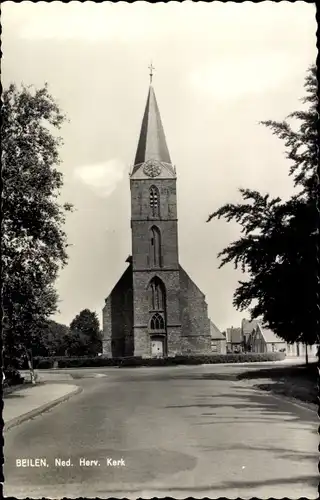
74, 158, 126, 198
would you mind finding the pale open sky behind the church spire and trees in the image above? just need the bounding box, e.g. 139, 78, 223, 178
2, 1, 317, 330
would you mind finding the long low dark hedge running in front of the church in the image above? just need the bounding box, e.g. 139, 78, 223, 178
34, 352, 285, 369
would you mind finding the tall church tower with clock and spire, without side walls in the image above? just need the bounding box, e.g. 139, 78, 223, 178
130, 85, 181, 356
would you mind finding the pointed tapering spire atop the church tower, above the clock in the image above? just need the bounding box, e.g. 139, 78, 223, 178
134, 84, 171, 165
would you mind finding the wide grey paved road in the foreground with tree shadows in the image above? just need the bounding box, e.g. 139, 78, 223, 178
4, 365, 319, 498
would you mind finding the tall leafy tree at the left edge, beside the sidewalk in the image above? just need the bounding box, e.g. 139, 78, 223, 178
1, 84, 72, 380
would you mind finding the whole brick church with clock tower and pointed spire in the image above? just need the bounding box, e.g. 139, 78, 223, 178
103, 75, 211, 358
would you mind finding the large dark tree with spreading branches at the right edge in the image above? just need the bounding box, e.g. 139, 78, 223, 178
207, 66, 319, 364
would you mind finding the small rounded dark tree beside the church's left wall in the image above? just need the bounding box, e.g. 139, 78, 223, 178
70, 309, 102, 355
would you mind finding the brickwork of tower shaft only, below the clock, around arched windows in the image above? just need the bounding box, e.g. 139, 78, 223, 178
130, 178, 180, 356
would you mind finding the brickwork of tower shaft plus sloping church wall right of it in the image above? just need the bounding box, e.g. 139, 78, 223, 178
130, 171, 211, 356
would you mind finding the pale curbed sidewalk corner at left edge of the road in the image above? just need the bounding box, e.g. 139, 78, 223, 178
2, 384, 82, 431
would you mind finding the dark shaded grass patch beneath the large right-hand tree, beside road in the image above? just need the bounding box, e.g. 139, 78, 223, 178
237, 363, 319, 404
